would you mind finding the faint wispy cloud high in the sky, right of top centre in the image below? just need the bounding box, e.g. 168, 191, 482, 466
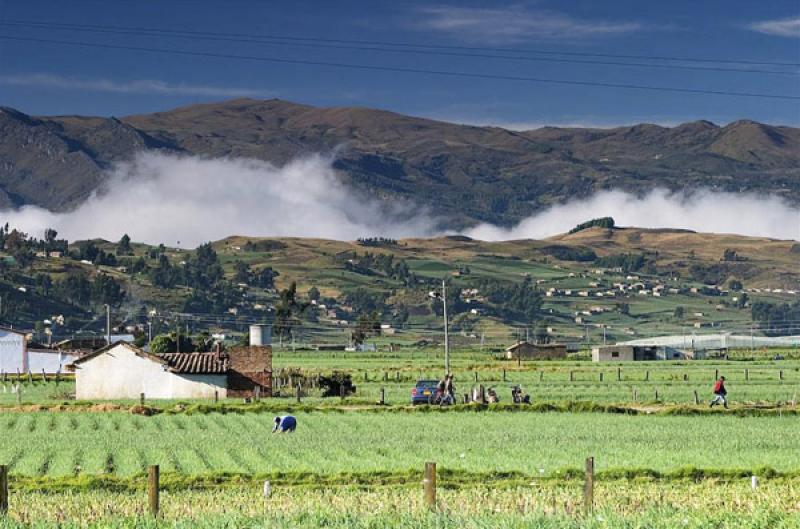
415, 5, 642, 44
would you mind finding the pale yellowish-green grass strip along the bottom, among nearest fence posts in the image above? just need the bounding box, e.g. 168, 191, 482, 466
0, 480, 800, 529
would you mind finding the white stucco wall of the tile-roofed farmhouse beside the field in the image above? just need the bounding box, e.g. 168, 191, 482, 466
75, 345, 227, 400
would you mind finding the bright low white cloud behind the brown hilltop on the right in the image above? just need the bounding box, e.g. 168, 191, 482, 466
465, 189, 800, 240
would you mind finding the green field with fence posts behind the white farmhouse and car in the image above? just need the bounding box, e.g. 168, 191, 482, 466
0, 348, 800, 406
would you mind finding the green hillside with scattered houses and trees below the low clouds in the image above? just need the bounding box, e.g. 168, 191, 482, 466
0, 223, 800, 344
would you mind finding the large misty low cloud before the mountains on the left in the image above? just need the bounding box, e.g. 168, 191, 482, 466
2, 153, 434, 247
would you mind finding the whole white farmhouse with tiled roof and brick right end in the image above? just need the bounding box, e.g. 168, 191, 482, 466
69, 324, 272, 400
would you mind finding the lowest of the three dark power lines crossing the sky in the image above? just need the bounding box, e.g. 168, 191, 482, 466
0, 35, 800, 101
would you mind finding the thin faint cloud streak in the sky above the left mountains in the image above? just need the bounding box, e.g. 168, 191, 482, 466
0, 73, 272, 97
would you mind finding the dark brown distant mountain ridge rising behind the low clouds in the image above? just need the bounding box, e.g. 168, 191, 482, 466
0, 99, 800, 229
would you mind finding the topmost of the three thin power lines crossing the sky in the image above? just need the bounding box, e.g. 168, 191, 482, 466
7, 19, 800, 66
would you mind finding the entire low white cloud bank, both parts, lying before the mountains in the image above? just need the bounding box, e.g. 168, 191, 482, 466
0, 153, 800, 247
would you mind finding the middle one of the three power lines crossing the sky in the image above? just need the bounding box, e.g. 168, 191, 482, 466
0, 21, 800, 76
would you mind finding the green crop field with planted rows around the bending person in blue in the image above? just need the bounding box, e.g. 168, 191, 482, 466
0, 411, 800, 480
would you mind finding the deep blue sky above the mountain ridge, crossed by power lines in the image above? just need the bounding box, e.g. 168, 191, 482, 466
0, 0, 800, 128
